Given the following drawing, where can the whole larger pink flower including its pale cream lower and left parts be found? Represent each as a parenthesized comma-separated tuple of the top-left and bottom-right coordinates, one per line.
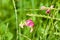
(19, 19, 34, 32)
